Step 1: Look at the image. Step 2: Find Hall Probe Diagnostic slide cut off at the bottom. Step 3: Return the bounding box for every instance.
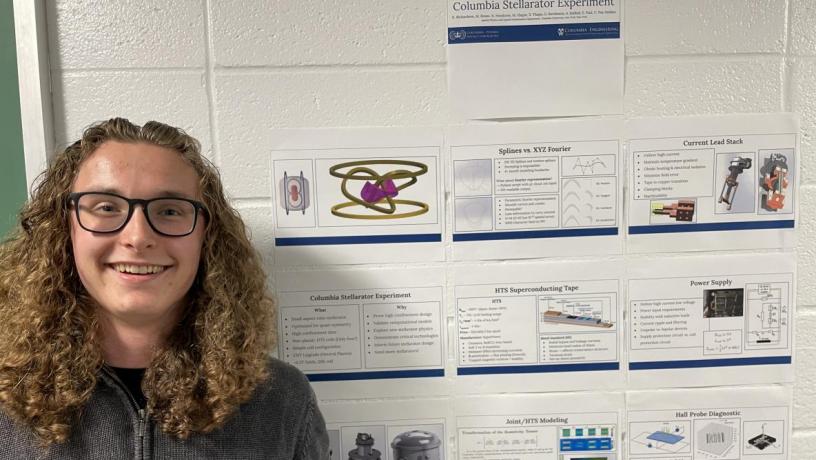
[626,386,792,460]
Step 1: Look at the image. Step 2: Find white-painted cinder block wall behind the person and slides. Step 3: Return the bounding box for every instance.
[46,0,816,459]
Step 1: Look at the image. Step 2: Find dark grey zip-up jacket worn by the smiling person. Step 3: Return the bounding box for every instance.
[0,359,329,460]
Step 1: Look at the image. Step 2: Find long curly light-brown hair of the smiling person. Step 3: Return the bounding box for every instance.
[0,118,275,445]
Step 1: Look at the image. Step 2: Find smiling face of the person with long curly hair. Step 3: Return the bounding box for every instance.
[71,141,206,327]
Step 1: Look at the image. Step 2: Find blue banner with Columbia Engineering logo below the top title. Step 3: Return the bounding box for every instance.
[448,22,620,45]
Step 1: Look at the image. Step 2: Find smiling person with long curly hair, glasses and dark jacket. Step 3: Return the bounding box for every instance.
[0,118,329,460]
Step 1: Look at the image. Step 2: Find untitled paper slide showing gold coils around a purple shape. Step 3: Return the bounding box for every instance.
[270,128,444,265]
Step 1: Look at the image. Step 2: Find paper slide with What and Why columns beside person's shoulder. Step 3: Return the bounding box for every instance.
[275,268,446,399]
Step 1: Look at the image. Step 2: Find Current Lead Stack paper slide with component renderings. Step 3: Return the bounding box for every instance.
[627,114,799,252]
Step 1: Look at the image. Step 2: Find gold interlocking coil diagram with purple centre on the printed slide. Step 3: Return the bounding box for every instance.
[329,160,429,219]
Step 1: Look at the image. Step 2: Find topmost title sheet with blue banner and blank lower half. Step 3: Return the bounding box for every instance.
[447,0,623,119]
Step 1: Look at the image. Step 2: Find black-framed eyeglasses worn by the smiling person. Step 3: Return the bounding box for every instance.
[68,192,207,236]
